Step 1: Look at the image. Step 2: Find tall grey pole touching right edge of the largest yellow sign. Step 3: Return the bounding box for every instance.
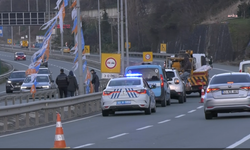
[121,0,124,75]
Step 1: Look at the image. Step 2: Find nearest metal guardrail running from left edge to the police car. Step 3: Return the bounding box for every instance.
[0,92,102,132]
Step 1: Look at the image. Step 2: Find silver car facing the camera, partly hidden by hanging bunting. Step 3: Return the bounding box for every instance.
[21,74,56,92]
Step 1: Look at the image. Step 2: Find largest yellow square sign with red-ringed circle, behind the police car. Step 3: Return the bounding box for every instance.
[101,53,121,73]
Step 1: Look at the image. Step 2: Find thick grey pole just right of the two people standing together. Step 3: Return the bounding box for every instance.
[76,0,84,95]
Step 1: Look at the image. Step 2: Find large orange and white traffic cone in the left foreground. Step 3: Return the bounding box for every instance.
[54,113,67,148]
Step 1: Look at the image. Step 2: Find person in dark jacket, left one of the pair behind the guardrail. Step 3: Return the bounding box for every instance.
[56,69,69,98]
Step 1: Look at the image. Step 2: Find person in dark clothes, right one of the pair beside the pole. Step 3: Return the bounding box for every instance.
[68,71,78,97]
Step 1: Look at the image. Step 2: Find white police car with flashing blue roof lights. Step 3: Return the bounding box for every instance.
[101,74,156,116]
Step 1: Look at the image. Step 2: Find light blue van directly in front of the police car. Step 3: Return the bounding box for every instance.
[125,64,170,107]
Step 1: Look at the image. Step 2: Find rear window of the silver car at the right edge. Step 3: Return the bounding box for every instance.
[210,74,250,84]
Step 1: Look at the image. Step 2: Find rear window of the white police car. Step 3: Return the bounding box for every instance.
[108,79,141,86]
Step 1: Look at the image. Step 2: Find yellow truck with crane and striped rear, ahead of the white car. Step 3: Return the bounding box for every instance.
[164,50,211,95]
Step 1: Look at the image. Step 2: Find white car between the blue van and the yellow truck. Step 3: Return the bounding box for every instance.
[165,69,186,103]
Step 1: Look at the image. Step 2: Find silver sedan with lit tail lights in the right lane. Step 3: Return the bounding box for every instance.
[204,72,250,119]
